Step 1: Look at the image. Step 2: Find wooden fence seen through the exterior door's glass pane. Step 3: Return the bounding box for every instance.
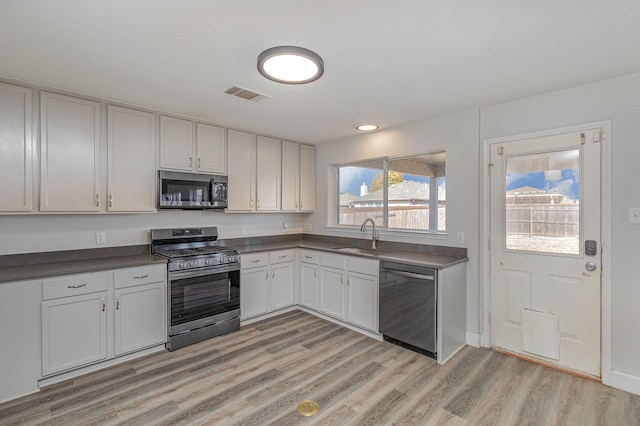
[506,204,580,237]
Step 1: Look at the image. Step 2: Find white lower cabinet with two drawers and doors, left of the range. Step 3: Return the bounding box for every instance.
[41,264,167,377]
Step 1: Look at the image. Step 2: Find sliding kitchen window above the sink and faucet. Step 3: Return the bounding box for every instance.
[336,151,447,232]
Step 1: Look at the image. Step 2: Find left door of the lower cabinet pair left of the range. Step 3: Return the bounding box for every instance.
[42,292,107,376]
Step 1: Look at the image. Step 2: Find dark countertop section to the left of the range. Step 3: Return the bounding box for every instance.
[0,254,167,284]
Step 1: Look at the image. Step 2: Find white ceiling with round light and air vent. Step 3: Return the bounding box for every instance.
[0,0,640,143]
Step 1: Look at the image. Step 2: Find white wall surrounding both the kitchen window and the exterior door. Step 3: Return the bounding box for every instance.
[310,74,640,394]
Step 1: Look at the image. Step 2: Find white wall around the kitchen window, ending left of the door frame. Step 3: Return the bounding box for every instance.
[308,108,479,335]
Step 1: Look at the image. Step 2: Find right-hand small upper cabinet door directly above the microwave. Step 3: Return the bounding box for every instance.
[196,123,227,175]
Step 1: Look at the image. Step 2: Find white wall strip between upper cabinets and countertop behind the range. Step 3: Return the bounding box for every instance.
[0,211,308,255]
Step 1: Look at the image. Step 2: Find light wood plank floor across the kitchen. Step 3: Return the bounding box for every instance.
[0,311,640,425]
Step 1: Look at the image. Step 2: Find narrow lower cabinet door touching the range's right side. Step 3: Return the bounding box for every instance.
[240,267,269,320]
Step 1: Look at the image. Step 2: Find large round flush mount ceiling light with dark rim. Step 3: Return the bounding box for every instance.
[258,46,324,84]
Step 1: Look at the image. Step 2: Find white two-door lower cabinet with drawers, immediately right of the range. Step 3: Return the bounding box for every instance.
[240,250,295,320]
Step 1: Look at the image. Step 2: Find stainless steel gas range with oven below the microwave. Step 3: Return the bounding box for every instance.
[151,227,240,351]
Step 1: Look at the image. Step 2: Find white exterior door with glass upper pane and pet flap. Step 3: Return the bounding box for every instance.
[490,128,603,376]
